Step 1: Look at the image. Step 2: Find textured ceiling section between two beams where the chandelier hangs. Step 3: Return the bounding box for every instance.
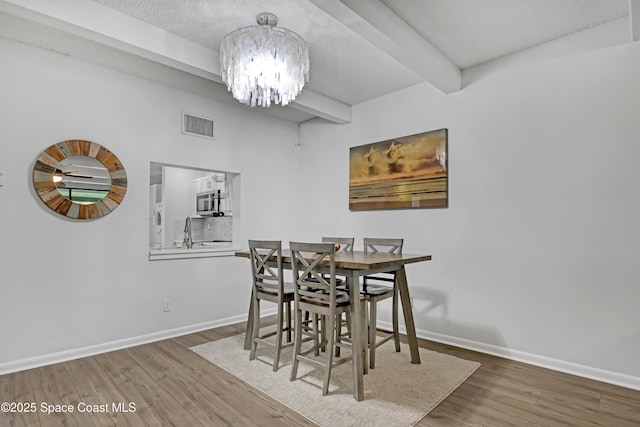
[86,0,421,105]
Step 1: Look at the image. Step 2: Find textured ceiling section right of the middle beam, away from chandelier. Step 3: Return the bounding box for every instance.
[383,0,629,69]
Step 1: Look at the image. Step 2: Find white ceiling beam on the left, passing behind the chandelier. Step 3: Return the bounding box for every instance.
[0,0,351,124]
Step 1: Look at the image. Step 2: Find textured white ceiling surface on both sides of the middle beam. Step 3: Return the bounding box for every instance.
[86,0,629,105]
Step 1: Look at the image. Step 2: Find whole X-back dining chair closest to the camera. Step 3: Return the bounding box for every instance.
[289,242,365,396]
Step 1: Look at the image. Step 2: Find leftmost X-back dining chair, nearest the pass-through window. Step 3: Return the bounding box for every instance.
[249,240,294,371]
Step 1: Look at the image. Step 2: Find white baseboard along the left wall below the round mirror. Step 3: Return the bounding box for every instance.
[0,310,250,375]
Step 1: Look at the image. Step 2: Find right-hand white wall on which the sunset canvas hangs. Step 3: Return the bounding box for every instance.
[302,43,640,388]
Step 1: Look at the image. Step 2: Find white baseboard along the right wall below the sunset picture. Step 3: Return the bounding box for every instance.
[378,322,640,390]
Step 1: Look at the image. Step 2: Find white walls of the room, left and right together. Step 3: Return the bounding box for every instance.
[0,30,640,388]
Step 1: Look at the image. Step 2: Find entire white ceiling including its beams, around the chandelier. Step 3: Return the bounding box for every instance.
[0,0,640,123]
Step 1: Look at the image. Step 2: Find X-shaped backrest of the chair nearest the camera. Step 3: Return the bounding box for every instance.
[289,242,336,312]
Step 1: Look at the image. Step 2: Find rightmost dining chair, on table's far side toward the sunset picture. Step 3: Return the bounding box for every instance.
[361,237,403,369]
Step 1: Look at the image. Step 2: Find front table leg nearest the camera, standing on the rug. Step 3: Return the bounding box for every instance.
[346,271,366,401]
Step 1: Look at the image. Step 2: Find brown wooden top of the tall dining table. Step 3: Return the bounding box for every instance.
[235,249,431,270]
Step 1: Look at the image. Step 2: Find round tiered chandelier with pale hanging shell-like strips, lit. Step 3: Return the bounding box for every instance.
[220,13,309,107]
